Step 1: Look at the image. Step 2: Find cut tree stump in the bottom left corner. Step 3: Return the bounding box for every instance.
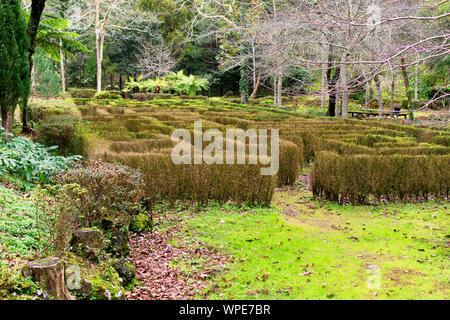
[24,257,75,300]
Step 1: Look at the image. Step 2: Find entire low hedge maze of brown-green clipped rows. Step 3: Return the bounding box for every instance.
[75,97,450,204]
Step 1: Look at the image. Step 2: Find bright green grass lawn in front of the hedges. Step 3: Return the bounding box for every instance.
[173,189,450,299]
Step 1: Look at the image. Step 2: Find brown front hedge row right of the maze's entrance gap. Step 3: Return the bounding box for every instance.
[312,151,450,204]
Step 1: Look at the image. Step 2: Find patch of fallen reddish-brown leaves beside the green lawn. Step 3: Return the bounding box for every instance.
[126,214,229,300]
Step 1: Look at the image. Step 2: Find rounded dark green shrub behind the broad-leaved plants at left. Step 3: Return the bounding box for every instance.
[37,117,87,155]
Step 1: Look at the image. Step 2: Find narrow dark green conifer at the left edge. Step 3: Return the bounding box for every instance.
[0,0,30,132]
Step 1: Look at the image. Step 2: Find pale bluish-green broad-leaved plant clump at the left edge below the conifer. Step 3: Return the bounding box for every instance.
[0,128,81,186]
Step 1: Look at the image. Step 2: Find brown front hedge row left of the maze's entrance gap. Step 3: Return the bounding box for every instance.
[104,154,277,205]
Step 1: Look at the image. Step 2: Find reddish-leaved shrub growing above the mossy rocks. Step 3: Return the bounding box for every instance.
[55,161,143,228]
